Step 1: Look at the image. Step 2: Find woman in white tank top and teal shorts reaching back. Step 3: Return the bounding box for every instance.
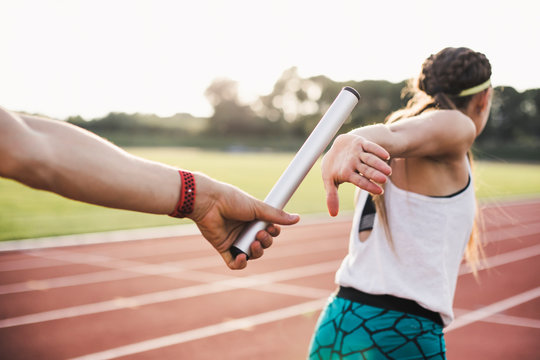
[309,48,492,359]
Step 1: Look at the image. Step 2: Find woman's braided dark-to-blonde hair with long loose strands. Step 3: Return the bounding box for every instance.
[373,48,491,276]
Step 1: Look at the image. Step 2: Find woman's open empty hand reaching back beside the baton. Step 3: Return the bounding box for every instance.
[321,134,392,216]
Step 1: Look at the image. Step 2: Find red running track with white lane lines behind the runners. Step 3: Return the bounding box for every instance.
[0,199,540,360]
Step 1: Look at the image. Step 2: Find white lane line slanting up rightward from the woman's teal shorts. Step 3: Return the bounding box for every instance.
[445,286,540,332]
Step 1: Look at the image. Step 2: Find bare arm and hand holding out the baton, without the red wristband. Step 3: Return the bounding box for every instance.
[0,108,299,269]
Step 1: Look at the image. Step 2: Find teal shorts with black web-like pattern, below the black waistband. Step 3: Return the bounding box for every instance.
[309,296,446,360]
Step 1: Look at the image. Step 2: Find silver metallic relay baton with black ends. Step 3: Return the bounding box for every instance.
[230,86,360,258]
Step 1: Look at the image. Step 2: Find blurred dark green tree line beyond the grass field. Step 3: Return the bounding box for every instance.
[68,67,540,160]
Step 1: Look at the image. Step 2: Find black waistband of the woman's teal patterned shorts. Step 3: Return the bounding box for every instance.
[336,286,443,326]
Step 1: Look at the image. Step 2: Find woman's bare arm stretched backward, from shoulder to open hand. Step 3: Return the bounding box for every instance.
[322,110,476,216]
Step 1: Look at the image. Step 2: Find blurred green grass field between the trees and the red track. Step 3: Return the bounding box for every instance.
[0,148,540,240]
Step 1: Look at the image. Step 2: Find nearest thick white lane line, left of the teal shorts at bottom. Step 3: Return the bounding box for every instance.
[72,298,327,360]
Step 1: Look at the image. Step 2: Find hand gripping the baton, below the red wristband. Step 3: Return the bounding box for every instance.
[189,173,300,269]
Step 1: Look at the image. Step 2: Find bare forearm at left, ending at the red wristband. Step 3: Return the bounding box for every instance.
[0,110,180,214]
